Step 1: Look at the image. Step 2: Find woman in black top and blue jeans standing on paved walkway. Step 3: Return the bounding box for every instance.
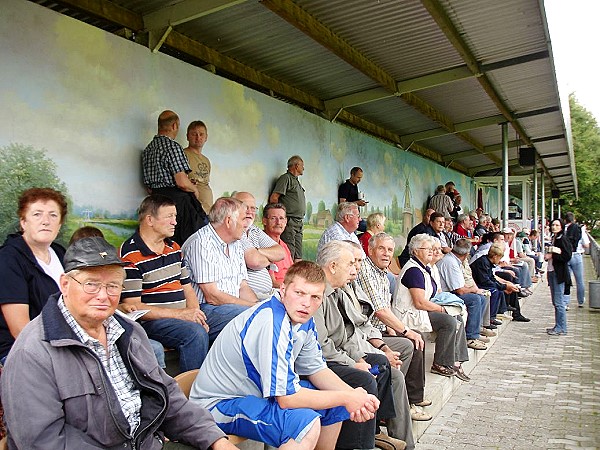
[544,219,572,336]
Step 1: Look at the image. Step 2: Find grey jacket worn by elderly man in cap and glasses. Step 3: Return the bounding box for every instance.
[1,293,224,450]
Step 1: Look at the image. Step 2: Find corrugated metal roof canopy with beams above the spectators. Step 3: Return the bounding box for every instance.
[30,0,577,195]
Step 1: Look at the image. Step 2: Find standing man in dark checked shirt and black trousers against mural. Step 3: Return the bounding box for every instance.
[142,110,207,245]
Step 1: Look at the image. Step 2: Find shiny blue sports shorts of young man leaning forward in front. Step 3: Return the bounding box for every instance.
[210,381,350,447]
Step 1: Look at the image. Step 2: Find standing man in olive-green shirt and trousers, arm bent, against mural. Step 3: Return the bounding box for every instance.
[269,155,306,261]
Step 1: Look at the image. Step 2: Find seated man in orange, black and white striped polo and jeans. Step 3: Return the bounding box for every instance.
[120,194,209,372]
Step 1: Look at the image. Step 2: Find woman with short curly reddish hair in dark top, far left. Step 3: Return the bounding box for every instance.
[0,188,67,363]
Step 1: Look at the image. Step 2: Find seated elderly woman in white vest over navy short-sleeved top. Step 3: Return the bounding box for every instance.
[392,234,469,381]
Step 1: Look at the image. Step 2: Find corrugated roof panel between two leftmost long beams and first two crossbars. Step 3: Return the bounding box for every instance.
[177,2,376,99]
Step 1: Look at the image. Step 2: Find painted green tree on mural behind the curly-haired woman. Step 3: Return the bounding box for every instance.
[0,144,71,243]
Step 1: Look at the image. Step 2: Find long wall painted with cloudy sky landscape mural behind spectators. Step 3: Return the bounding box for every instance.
[0,0,478,257]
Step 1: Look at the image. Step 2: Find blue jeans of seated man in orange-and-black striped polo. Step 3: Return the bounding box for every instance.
[141,319,208,372]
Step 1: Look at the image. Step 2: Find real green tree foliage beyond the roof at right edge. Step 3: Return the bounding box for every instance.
[562,94,600,227]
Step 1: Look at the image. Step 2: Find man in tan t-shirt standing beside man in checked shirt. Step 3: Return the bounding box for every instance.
[183,120,213,214]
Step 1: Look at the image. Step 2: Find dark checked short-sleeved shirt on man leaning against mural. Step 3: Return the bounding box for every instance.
[142,135,191,189]
